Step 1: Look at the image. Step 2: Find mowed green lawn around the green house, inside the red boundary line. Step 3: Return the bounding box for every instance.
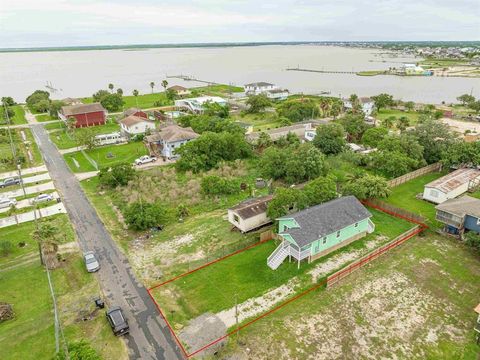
[153,209,412,324]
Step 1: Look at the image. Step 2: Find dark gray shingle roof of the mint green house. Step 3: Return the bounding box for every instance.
[280,196,372,247]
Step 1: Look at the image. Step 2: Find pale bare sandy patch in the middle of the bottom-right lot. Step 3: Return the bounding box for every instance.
[284,272,465,359]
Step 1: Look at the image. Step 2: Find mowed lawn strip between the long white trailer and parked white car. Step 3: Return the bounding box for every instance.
[63,142,147,172]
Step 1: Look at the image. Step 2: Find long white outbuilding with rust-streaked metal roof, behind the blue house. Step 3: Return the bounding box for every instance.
[423,168,480,204]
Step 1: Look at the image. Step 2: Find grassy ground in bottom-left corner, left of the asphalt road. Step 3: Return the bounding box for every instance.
[0,215,126,360]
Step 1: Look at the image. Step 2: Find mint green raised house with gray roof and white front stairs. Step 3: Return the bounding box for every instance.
[267,196,375,270]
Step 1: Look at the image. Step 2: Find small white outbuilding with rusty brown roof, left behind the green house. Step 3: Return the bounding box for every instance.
[228,195,273,233]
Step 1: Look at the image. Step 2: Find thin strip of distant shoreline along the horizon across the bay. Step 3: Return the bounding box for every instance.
[0,41,480,53]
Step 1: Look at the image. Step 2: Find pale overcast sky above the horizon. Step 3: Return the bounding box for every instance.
[0,0,480,48]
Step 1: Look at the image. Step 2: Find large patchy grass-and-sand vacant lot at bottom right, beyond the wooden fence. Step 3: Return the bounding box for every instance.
[219,233,480,360]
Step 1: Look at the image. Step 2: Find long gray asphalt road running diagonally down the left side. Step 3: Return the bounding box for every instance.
[30,124,183,360]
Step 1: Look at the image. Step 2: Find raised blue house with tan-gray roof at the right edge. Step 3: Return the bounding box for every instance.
[435,195,480,235]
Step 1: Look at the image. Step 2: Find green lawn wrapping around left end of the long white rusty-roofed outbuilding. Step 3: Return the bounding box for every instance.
[385,172,445,227]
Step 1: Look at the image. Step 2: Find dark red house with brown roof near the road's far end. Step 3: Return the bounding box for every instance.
[58,103,107,128]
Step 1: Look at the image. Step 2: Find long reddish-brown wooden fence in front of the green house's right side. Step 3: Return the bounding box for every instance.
[327,225,424,288]
